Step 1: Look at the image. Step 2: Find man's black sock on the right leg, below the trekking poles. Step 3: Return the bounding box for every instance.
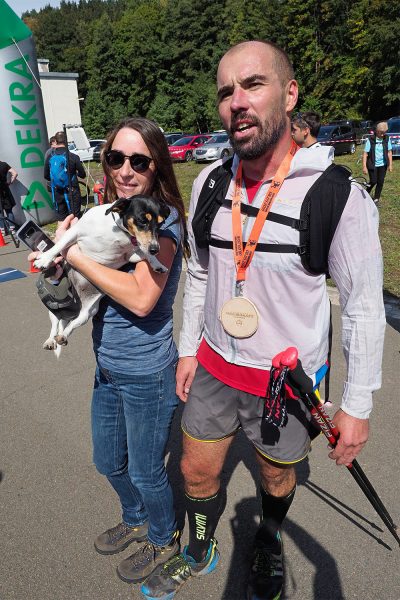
[256,486,296,546]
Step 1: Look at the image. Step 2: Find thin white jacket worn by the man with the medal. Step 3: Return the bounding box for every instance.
[179,147,386,418]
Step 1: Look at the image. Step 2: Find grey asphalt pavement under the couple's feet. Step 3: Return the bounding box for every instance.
[0,243,400,600]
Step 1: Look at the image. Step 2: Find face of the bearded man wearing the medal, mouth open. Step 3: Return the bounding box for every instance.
[217,42,297,160]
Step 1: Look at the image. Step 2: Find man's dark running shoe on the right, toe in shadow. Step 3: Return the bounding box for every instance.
[247,531,283,600]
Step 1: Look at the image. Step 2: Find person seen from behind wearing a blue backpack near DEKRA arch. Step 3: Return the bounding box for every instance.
[44,131,86,221]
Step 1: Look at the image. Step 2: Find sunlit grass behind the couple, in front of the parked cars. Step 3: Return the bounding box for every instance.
[54,146,400,297]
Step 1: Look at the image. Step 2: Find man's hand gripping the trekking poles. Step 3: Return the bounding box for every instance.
[329,409,369,466]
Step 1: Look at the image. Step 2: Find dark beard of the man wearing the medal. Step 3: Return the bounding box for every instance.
[229,111,287,160]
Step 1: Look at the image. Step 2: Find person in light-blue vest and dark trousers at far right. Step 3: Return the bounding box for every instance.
[363,121,393,205]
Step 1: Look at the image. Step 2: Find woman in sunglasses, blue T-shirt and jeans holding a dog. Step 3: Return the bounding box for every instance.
[52,118,186,582]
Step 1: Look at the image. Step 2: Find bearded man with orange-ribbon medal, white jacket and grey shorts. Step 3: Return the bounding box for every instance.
[142,41,385,600]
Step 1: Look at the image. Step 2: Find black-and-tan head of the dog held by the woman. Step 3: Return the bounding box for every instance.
[106,194,170,254]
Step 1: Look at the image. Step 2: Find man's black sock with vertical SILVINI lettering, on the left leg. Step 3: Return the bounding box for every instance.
[185,489,223,562]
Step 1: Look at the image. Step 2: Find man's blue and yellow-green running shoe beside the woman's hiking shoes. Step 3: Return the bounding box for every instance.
[140,538,219,600]
